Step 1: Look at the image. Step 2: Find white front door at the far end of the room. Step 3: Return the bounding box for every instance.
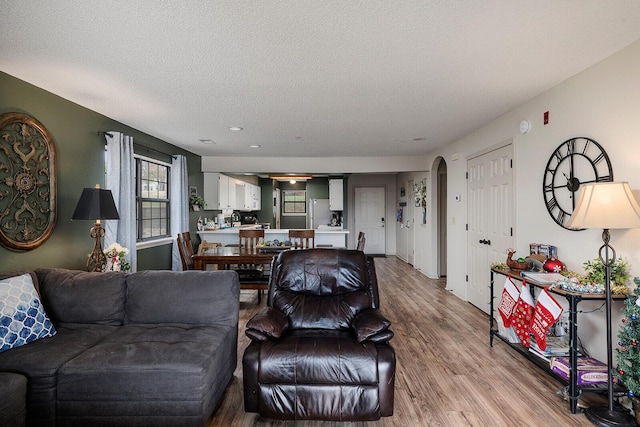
[354,187,386,254]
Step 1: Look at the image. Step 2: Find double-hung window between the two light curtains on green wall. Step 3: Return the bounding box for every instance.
[135,156,171,242]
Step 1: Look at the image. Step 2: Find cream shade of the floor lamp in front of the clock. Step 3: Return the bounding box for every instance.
[567,182,640,229]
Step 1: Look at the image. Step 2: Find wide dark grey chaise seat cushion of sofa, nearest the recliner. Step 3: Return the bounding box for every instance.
[58,324,238,425]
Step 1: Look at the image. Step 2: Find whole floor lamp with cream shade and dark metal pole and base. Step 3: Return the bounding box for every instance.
[567,182,640,426]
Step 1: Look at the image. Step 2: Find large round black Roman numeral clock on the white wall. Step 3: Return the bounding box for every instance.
[542,137,613,230]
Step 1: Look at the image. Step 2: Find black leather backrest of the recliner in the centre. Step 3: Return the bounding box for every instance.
[267,249,378,330]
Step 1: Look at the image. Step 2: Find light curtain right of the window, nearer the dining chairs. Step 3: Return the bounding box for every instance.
[169,156,189,271]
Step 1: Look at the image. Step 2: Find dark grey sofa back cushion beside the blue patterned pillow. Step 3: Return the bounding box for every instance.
[35,268,127,325]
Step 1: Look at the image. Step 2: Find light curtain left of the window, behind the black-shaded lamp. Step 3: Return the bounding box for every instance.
[104,131,137,272]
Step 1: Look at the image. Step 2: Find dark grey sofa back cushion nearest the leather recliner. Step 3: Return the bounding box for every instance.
[126,271,240,325]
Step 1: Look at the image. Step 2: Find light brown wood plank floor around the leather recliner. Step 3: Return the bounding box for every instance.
[209,257,591,427]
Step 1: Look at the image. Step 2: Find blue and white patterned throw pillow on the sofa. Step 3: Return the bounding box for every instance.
[0,274,56,352]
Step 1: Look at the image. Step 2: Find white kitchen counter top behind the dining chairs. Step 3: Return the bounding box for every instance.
[198,229,349,248]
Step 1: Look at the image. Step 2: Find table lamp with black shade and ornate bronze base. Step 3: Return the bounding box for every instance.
[71,184,120,271]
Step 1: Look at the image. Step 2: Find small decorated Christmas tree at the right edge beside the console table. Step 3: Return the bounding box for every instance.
[615,277,640,397]
